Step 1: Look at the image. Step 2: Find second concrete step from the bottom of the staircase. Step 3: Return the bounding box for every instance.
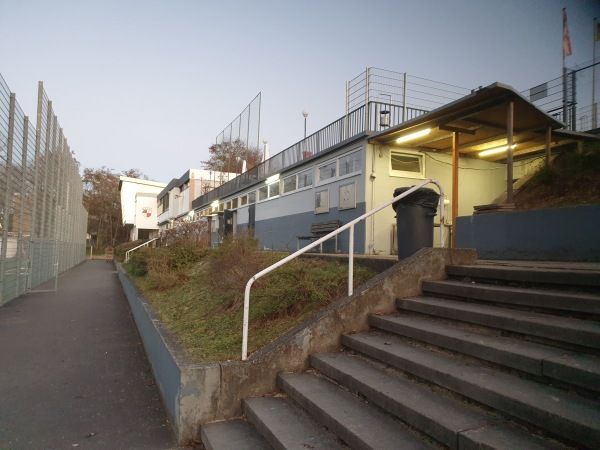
[243,397,345,450]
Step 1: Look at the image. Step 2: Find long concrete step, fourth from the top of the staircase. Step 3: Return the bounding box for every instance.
[369,314,600,392]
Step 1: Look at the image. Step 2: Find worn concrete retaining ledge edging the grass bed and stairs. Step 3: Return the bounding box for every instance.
[118,248,477,445]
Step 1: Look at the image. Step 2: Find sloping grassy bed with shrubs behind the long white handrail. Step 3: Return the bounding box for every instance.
[125,234,376,362]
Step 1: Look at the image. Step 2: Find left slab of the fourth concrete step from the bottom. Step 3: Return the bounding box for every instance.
[311,353,502,449]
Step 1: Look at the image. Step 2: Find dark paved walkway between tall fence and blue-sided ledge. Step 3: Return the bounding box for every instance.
[0,261,177,450]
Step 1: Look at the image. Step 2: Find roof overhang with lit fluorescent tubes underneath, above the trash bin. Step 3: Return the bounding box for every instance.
[369,83,573,162]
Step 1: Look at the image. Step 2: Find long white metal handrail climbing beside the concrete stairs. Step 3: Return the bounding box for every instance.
[242,179,444,360]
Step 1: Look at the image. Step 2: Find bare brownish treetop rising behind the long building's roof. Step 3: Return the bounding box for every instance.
[202,139,262,173]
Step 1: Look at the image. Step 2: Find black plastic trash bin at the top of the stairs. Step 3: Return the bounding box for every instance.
[392,187,440,259]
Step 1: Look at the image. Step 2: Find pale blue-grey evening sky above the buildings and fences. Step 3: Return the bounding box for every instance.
[0,0,600,182]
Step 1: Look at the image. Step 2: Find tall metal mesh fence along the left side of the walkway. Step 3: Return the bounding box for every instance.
[0,75,87,305]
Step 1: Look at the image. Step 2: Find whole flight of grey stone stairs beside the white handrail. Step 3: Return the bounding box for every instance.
[201,263,600,450]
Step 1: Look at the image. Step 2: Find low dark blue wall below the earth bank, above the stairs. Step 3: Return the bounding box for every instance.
[455,205,600,262]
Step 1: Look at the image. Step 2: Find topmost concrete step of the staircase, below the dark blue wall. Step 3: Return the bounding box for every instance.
[446,263,600,288]
